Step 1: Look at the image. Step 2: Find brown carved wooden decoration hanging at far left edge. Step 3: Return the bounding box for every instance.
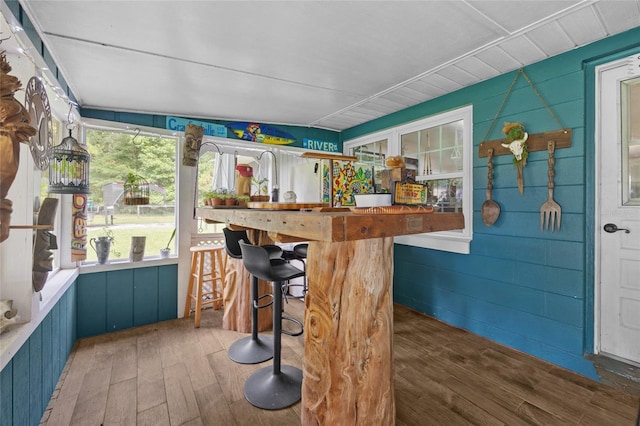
[0,46,36,242]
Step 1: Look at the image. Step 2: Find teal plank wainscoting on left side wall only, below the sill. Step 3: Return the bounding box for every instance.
[0,282,77,426]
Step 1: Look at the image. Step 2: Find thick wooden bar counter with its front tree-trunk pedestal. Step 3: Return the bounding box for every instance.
[196,207,464,425]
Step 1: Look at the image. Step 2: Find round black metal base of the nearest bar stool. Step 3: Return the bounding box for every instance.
[244,365,302,410]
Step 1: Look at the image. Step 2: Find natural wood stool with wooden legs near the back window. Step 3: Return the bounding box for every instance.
[184,246,225,328]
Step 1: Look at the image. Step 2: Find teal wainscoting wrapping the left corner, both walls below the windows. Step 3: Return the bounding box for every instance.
[0,265,178,426]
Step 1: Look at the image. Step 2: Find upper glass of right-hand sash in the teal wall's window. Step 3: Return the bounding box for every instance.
[400,120,463,176]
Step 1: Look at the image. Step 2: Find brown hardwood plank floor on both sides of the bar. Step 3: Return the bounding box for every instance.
[41,300,640,426]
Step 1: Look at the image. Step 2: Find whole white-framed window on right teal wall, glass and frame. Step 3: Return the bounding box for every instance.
[344,106,473,253]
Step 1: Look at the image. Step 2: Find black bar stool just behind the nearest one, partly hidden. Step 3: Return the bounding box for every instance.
[222,228,282,364]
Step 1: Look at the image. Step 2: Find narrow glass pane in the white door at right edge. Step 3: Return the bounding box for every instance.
[622,78,640,205]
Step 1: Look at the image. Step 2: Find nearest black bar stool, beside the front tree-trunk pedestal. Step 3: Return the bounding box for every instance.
[240,241,304,410]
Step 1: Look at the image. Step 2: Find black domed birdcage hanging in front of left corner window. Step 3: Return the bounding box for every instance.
[49,129,91,194]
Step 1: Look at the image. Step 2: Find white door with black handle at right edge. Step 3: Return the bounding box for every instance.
[596,55,640,363]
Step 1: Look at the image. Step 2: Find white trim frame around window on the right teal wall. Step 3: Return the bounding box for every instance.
[343,105,473,254]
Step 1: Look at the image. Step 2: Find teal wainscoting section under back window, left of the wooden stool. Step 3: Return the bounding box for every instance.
[77,265,178,338]
